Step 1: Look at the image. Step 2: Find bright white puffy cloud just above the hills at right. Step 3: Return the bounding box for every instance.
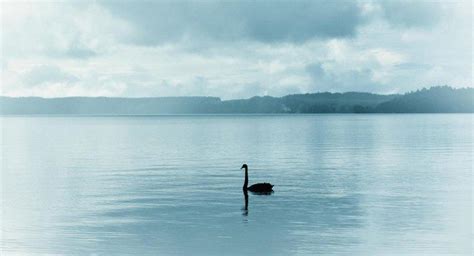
[305,40,407,93]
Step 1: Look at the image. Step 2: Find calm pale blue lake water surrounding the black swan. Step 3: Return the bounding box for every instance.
[0,114,474,255]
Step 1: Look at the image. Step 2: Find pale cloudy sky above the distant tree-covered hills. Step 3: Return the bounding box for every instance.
[0,0,473,99]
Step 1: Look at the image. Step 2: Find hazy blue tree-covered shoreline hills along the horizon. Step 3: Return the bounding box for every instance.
[0,86,474,115]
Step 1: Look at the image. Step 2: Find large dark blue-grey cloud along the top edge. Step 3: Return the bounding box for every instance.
[101,0,363,45]
